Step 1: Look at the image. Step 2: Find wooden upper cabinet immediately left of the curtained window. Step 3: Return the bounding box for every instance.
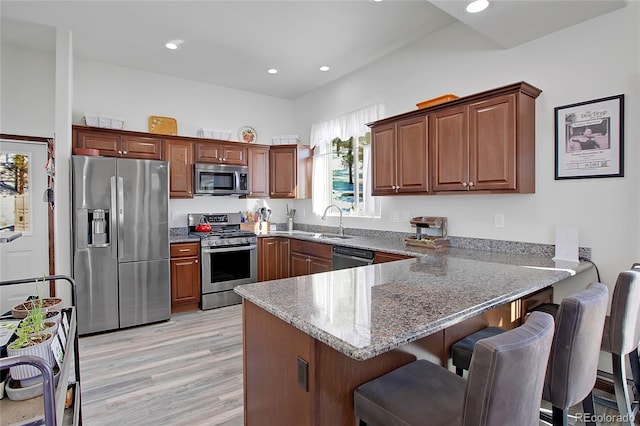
[269,145,311,198]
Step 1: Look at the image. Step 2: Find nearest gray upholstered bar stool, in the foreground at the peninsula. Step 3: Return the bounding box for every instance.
[354,312,554,426]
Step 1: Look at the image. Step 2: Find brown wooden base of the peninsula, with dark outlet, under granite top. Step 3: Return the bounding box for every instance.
[242,300,415,426]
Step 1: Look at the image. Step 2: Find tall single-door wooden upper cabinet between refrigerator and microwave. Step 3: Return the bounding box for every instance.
[164,140,193,198]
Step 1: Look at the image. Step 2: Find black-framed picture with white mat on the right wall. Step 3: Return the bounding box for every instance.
[554,95,624,180]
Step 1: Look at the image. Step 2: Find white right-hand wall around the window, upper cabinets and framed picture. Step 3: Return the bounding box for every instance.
[294,2,640,285]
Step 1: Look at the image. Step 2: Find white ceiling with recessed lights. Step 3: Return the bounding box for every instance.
[0,0,626,99]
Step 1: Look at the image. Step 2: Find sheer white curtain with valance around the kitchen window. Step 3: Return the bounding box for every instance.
[309,103,384,215]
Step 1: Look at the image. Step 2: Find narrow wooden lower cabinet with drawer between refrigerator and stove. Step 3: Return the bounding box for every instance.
[171,243,200,312]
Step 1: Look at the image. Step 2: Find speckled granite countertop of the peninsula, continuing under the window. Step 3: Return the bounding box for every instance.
[235,243,593,360]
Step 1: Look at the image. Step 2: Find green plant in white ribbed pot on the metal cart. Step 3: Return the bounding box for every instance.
[7,297,57,380]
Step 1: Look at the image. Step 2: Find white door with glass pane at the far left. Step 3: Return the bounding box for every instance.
[0,139,49,314]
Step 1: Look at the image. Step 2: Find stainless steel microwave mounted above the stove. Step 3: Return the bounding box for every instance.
[193,163,249,195]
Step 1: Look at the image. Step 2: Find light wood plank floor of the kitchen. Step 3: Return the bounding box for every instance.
[80,305,640,426]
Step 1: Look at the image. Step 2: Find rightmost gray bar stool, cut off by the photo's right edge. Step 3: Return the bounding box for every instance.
[597,265,640,425]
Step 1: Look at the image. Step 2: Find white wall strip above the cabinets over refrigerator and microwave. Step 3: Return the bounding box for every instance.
[73,58,293,144]
